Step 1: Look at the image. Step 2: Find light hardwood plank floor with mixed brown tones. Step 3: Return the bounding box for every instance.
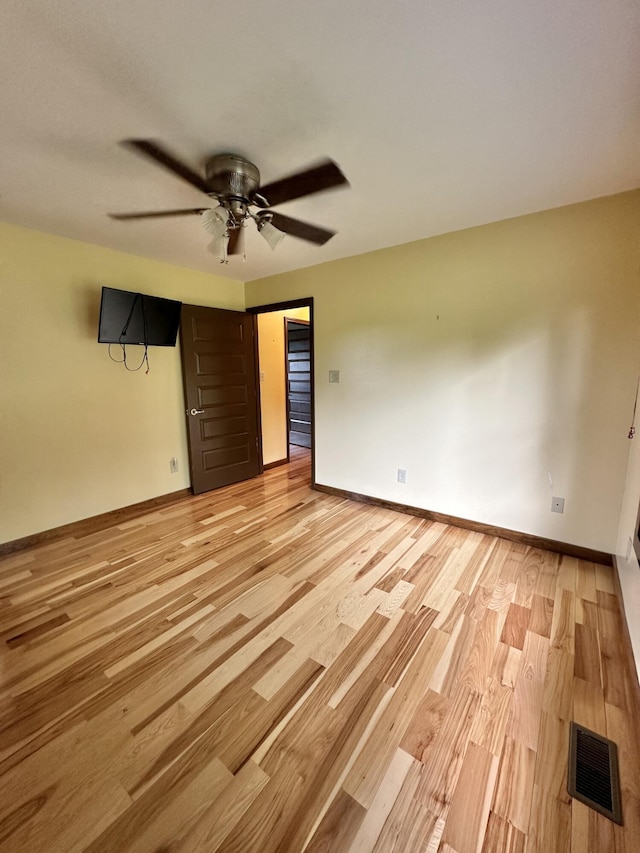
[0,454,640,853]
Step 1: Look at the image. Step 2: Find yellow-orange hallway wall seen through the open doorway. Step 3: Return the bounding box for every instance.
[258,308,309,465]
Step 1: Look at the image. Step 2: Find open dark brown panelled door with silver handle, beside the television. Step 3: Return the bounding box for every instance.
[180,305,261,494]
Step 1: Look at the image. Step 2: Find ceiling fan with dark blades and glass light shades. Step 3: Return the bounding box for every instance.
[108,139,349,263]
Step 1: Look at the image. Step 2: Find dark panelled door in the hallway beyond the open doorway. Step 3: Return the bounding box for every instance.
[284,318,311,447]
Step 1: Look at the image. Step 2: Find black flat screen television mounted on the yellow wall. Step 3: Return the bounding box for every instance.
[98,287,182,347]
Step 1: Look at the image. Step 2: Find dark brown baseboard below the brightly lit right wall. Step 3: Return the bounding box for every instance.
[314,483,613,566]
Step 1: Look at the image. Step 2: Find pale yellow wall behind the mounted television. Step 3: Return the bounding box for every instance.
[0,224,244,541]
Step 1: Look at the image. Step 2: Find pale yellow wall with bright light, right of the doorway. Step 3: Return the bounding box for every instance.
[246,191,640,553]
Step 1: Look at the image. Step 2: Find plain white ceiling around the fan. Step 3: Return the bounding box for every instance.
[0,0,640,281]
